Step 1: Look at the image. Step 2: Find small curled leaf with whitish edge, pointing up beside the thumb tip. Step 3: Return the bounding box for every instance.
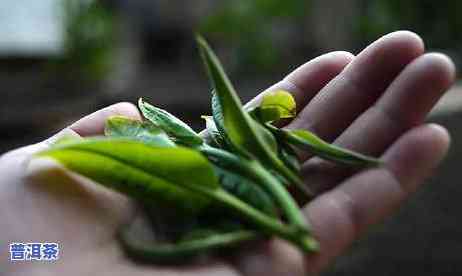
[138,99,203,146]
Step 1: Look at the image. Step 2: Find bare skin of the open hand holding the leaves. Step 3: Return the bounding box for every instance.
[0,31,455,276]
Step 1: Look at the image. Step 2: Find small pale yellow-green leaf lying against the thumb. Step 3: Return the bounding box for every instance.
[104,116,176,147]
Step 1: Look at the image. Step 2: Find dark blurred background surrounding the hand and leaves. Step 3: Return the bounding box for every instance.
[0,0,462,275]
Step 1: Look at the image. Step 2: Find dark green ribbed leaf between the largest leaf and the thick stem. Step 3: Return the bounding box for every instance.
[214,166,277,217]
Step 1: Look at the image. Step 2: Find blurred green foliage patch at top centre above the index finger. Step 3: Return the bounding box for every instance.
[199,0,307,71]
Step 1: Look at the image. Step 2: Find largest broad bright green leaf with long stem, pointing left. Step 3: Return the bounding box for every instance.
[35,138,316,254]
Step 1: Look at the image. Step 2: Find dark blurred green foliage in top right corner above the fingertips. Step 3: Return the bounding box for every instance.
[356,0,462,51]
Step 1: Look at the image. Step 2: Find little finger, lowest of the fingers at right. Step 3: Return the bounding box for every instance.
[306,125,449,270]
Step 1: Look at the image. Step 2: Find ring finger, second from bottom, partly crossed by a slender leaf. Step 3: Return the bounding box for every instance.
[303,54,455,192]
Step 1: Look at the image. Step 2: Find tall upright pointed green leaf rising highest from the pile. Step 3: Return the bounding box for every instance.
[197,37,313,229]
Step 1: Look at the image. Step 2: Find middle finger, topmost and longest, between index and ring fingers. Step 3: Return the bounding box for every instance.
[289,31,424,141]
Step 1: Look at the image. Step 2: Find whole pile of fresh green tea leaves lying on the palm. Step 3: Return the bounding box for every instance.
[37,37,380,263]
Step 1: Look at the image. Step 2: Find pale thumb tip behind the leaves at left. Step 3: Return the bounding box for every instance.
[70,102,141,136]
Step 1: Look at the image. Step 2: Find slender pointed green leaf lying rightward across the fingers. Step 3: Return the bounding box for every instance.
[279,129,381,166]
